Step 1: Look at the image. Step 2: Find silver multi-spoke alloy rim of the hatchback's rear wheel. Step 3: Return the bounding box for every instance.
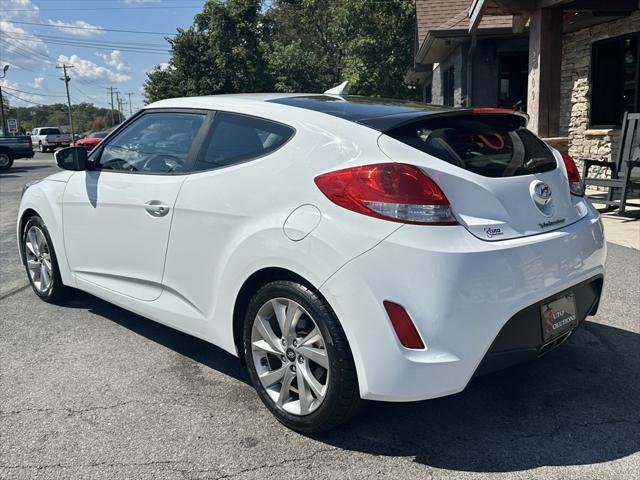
[251,298,329,416]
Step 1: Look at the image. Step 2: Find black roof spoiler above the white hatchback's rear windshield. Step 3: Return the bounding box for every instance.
[356,107,529,133]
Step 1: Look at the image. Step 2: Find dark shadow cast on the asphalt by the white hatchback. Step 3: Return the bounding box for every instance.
[65,293,640,472]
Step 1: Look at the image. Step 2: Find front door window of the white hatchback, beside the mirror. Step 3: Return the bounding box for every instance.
[99,113,205,173]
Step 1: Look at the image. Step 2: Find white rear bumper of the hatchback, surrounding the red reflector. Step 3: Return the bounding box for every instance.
[321,205,606,401]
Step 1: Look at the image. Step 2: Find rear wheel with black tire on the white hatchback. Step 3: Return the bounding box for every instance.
[243,281,364,433]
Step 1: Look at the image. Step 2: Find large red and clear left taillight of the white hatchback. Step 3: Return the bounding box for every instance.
[315,163,458,225]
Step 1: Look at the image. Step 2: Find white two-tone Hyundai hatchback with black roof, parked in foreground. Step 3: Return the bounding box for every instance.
[17,94,605,432]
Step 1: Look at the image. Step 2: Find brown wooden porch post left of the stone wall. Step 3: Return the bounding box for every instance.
[527,8,562,137]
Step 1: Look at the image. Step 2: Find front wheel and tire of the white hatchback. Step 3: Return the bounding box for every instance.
[21,215,72,303]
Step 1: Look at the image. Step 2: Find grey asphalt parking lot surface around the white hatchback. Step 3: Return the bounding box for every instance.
[0,154,640,479]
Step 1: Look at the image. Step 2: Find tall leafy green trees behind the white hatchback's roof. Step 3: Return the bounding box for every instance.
[144,0,415,102]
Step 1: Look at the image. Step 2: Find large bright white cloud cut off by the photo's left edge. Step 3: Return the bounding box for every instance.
[0,20,51,69]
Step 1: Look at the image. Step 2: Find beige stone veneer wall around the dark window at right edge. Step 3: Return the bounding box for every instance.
[560,11,640,174]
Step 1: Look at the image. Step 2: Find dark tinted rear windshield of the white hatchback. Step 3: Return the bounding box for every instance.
[386,113,557,177]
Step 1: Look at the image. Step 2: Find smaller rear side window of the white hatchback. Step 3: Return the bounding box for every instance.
[194,112,294,170]
